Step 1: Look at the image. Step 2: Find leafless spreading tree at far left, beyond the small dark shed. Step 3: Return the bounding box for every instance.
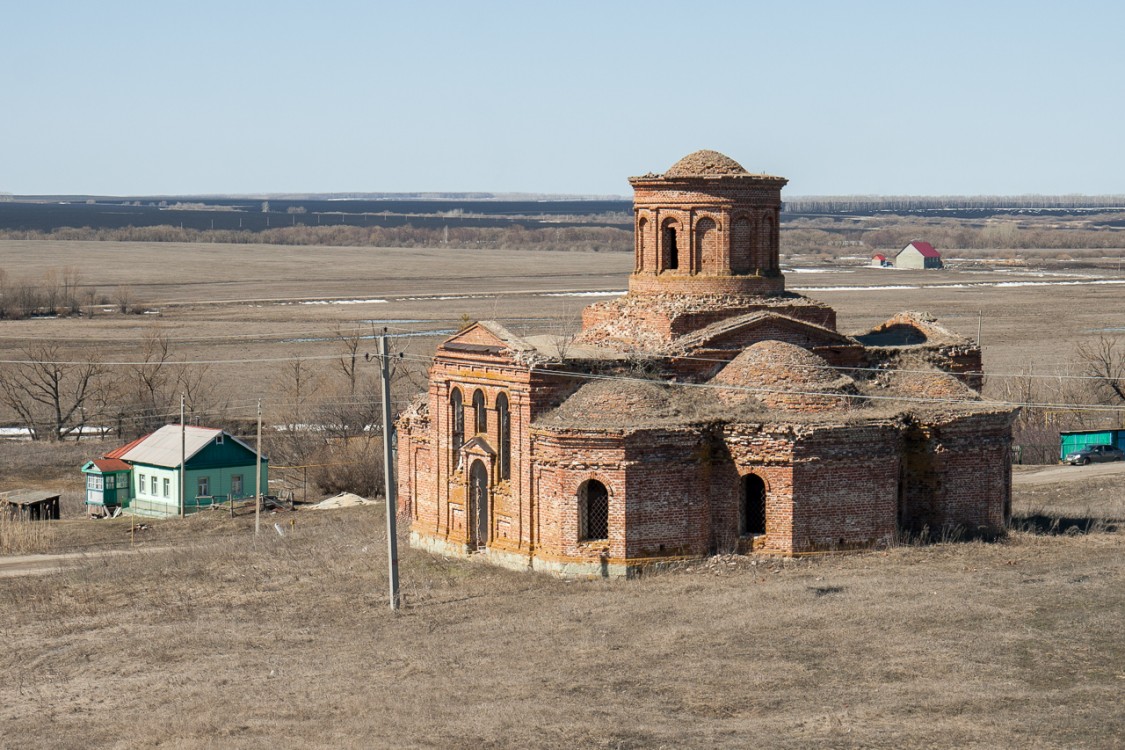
[0,344,105,441]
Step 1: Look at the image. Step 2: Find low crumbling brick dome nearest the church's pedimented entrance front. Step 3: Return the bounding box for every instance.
[541,380,681,427]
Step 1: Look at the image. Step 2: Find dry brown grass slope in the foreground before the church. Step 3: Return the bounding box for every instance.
[0,469,1125,749]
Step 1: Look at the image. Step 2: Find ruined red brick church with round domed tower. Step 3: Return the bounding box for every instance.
[398,151,1014,576]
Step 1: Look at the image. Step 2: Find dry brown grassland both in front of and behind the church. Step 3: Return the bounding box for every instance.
[0,242,1125,750]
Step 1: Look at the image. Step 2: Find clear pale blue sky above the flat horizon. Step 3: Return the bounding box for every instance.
[0,0,1125,196]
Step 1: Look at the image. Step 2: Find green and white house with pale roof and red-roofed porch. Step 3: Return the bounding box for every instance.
[83,425,269,516]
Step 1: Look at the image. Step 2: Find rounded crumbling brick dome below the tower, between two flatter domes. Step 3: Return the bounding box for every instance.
[711,341,858,412]
